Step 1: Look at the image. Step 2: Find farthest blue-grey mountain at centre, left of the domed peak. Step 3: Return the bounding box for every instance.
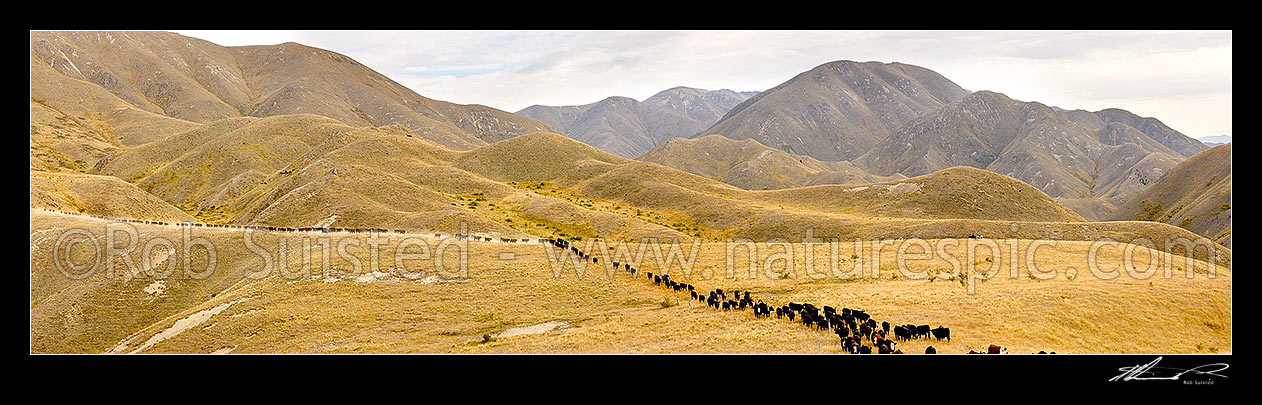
[517,87,750,158]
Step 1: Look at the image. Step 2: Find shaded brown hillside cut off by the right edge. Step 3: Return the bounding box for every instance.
[1113,144,1232,247]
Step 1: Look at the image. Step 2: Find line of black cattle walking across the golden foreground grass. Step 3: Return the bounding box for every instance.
[550,240,989,355]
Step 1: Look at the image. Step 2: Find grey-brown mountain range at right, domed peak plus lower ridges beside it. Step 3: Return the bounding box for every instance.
[593,61,1208,220]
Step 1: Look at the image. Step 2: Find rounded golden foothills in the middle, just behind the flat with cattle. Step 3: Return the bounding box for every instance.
[93,126,1225,264]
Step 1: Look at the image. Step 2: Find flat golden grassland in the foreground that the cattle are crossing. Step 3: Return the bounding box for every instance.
[32,211,1232,353]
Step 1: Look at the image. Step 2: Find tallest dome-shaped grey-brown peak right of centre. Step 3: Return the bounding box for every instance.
[695,61,968,161]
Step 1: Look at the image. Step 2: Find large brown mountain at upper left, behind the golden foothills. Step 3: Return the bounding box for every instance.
[30,32,551,150]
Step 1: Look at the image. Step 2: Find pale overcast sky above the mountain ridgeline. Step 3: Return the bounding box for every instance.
[179,30,1232,138]
